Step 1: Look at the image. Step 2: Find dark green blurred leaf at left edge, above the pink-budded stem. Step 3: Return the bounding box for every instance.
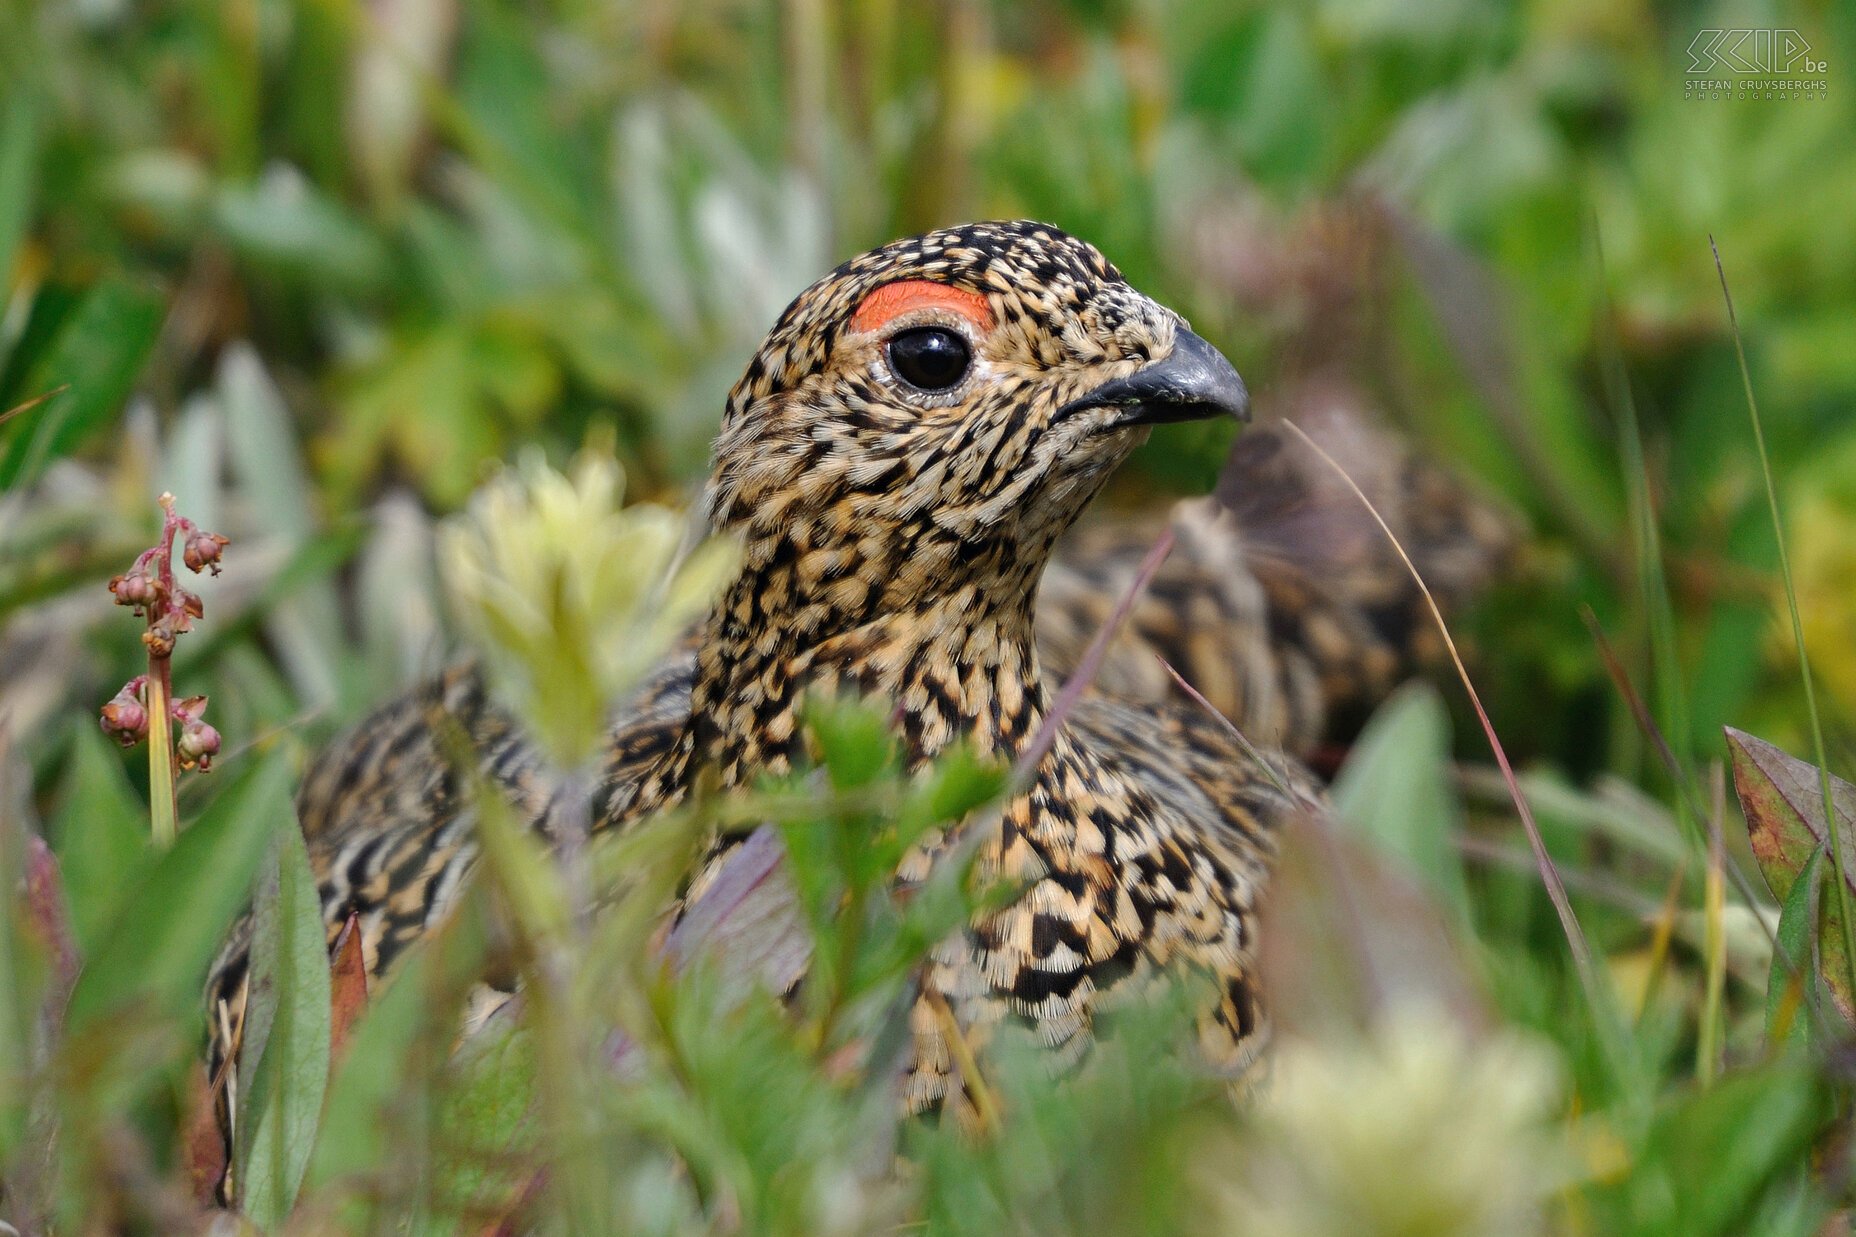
[0,279,165,490]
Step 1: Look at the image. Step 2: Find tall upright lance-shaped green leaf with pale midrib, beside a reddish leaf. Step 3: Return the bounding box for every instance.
[236,813,330,1230]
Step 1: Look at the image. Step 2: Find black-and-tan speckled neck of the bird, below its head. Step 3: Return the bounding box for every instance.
[692,544,1045,786]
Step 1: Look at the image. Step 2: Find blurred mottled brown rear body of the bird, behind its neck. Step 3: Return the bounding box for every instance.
[1038,416,1514,754]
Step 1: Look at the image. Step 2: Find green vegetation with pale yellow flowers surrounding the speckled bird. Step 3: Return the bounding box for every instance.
[0,0,1856,1233]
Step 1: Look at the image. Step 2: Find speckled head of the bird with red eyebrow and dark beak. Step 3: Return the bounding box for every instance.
[709,221,1247,617]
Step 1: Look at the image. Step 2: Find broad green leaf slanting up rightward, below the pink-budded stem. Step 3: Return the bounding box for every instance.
[69,756,291,1029]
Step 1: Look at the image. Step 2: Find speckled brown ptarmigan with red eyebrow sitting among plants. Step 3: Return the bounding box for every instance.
[210,223,1490,1136]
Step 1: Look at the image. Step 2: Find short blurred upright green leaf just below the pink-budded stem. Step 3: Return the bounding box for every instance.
[52,719,152,957]
